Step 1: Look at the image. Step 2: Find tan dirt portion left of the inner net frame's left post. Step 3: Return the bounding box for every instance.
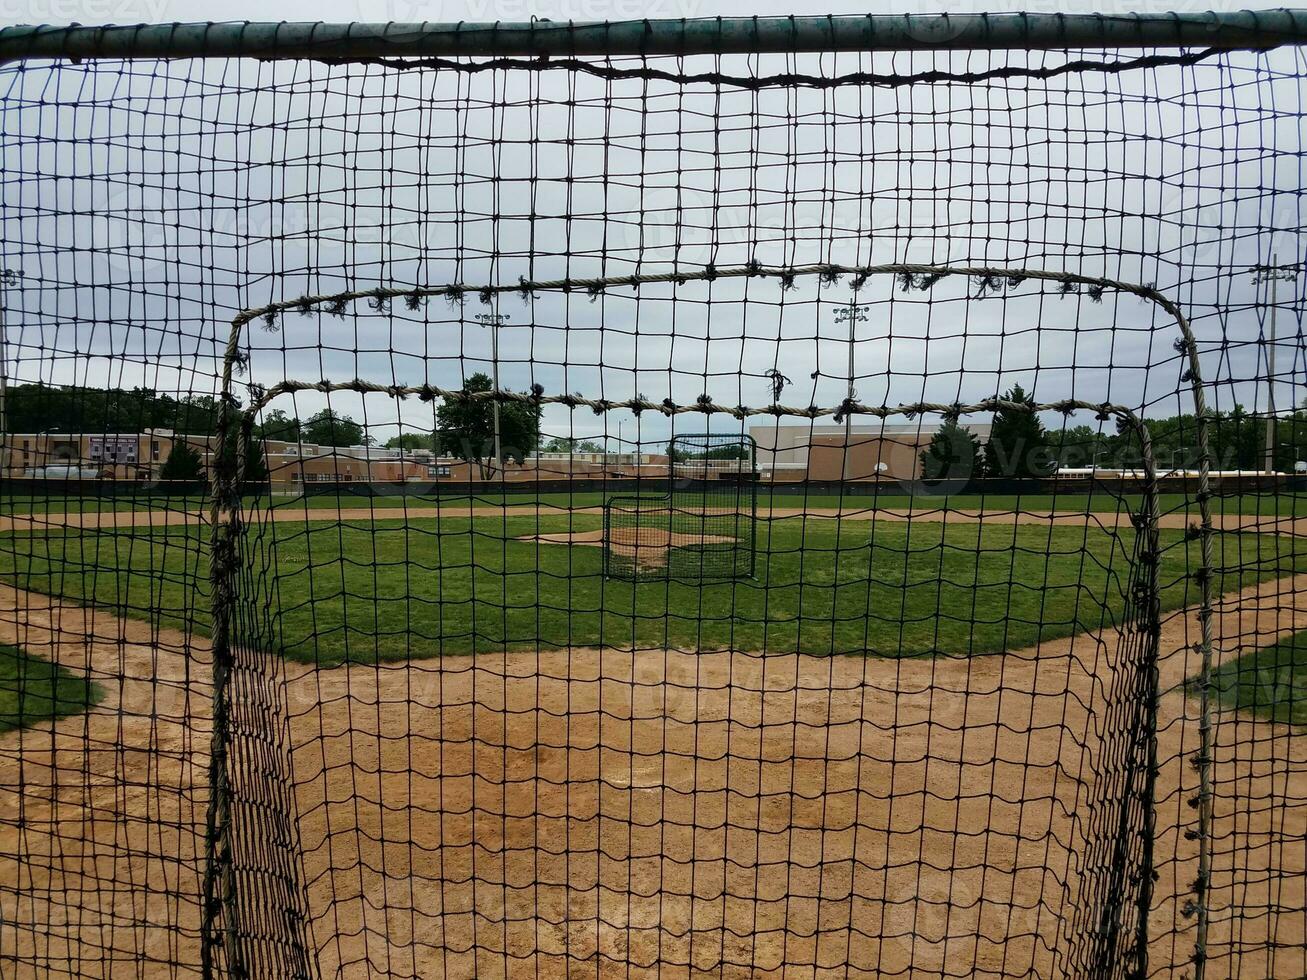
[0,585,212,980]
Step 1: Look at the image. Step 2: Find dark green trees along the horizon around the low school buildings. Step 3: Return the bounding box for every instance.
[5,372,1307,481]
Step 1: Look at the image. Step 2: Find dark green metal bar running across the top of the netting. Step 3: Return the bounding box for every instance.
[0,9,1307,64]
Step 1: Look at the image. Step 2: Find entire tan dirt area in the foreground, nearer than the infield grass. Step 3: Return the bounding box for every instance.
[0,575,1307,977]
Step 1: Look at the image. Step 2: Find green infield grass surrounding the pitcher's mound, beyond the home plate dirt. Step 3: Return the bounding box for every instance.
[0,515,1307,664]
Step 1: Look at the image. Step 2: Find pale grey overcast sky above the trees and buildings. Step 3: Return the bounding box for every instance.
[0,0,1307,452]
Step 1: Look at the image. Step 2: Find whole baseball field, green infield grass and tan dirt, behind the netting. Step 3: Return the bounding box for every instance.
[0,503,1307,977]
